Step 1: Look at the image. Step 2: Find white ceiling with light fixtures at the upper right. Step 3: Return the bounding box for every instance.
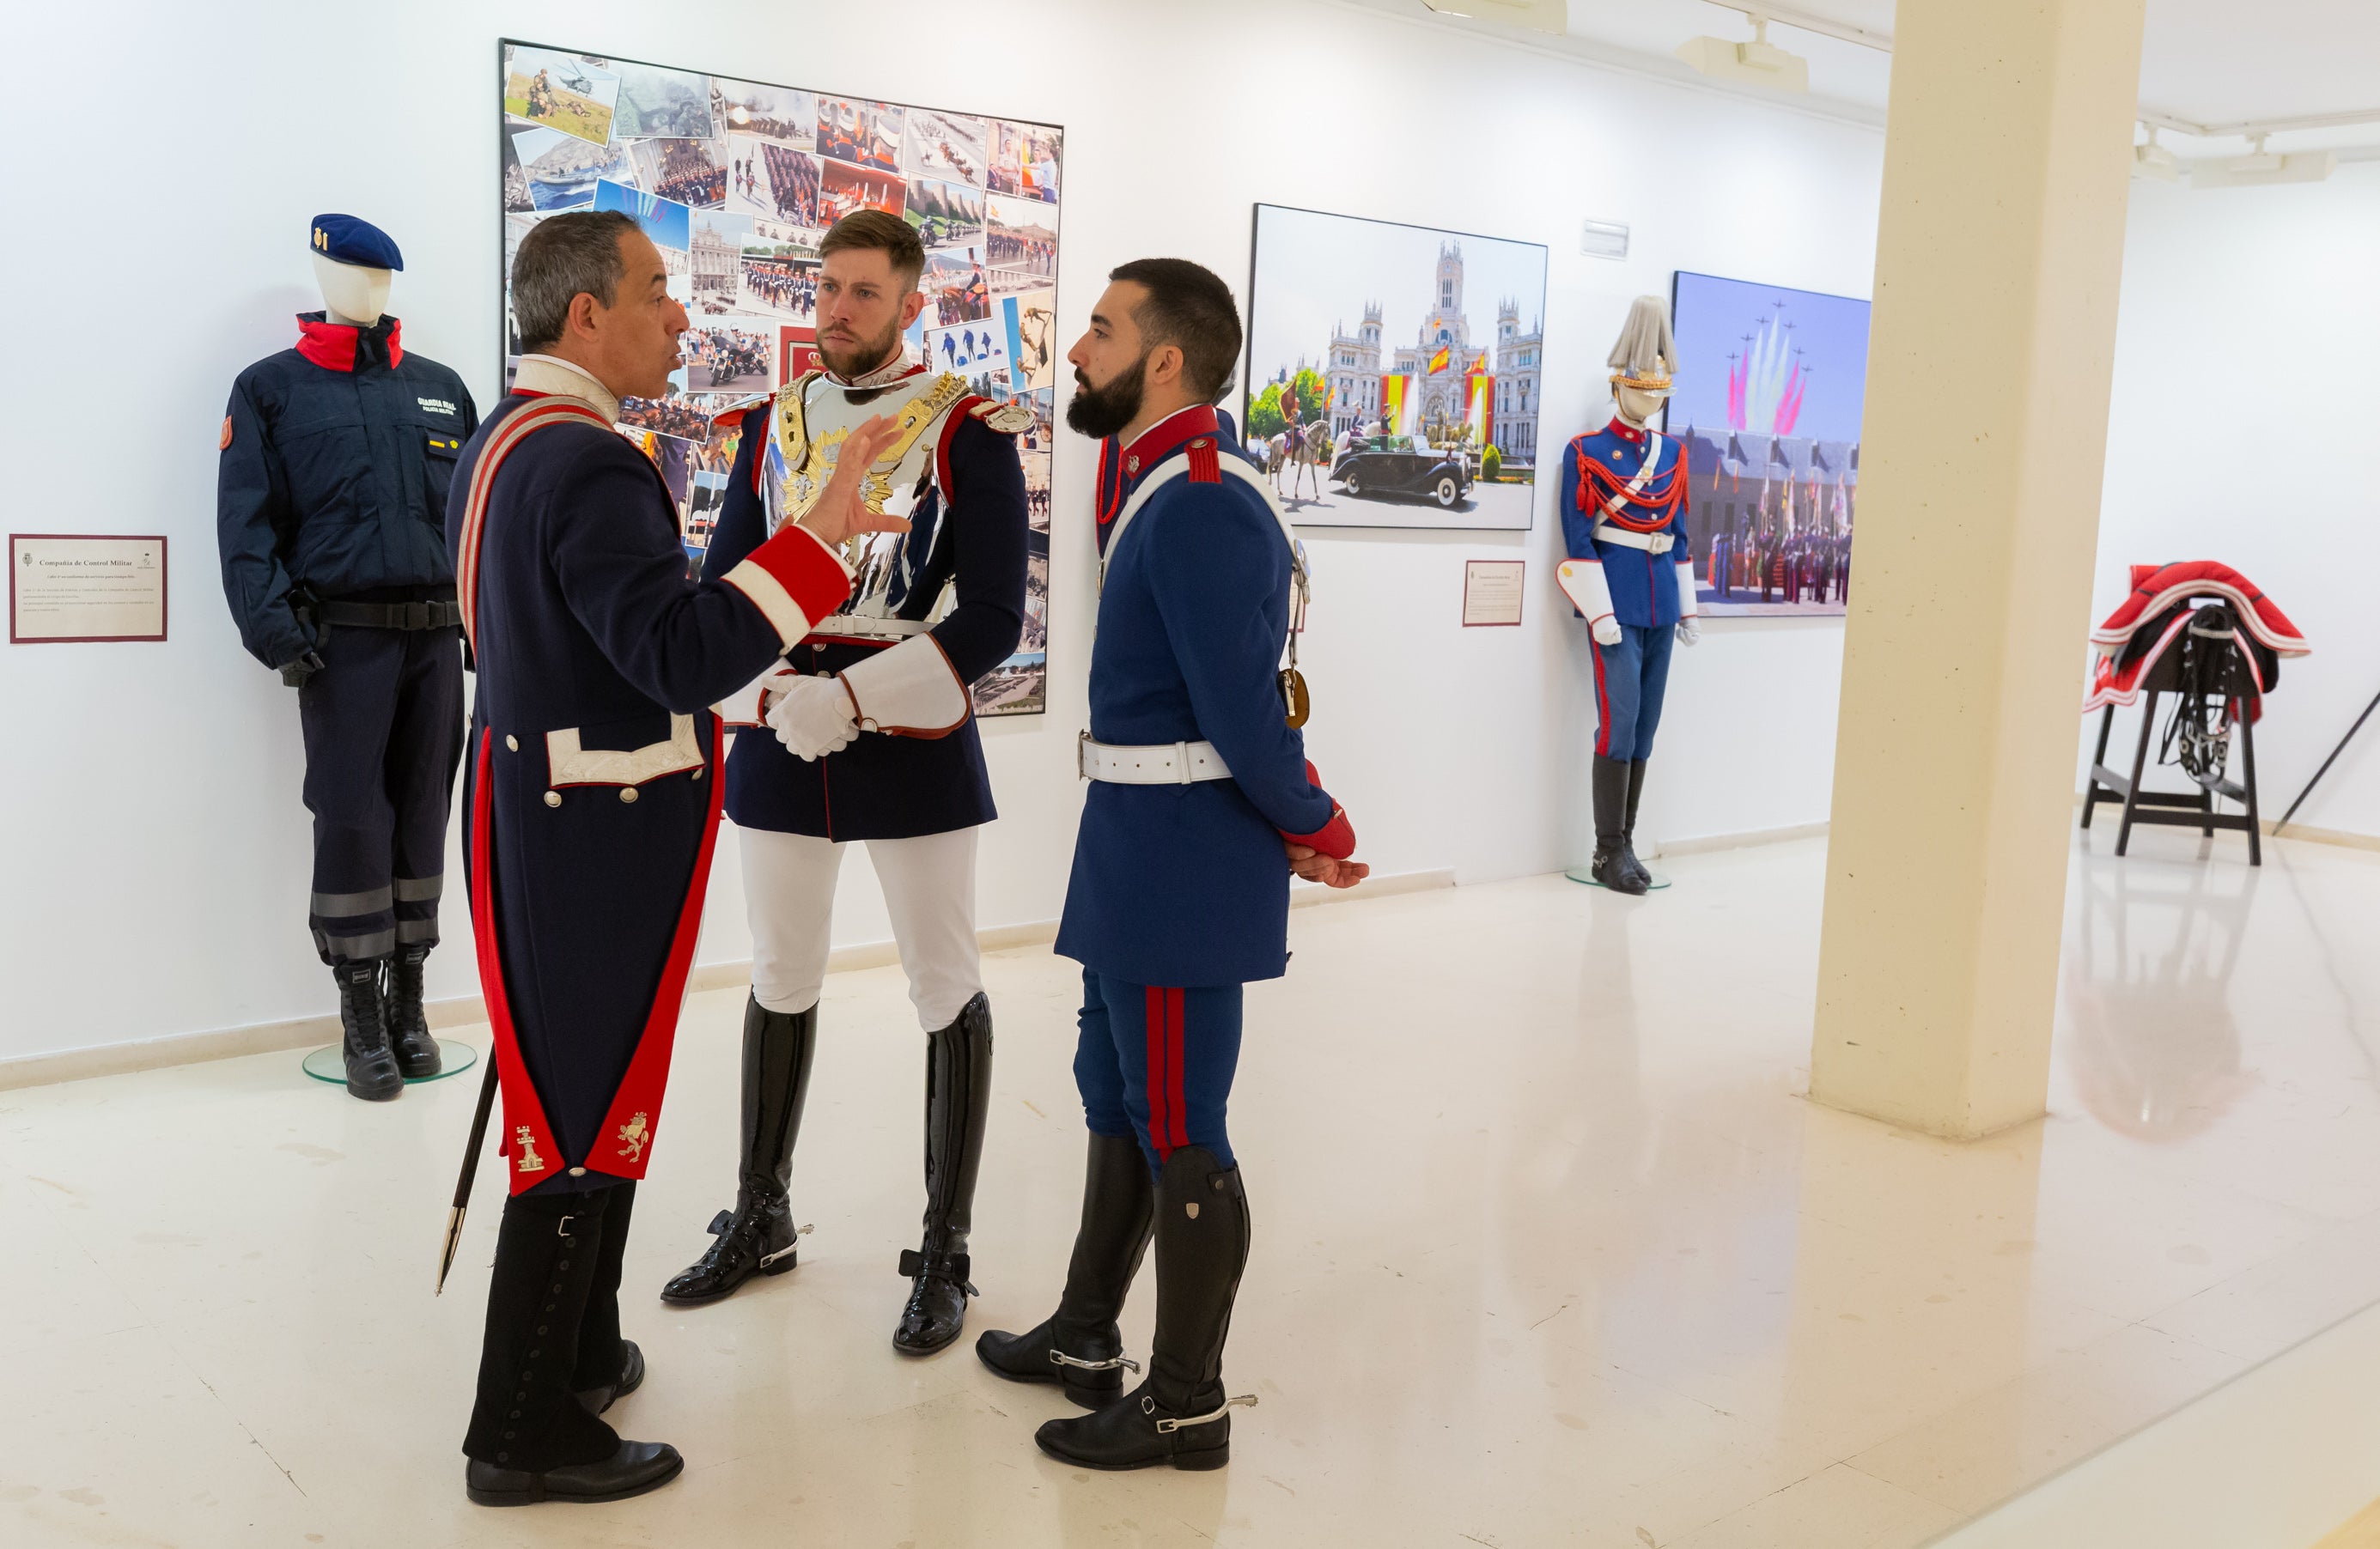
[1354,0,2380,157]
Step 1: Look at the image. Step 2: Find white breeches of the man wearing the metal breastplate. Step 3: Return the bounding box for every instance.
[735,828,983,1030]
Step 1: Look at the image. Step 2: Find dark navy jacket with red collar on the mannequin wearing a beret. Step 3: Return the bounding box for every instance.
[214,312,478,666]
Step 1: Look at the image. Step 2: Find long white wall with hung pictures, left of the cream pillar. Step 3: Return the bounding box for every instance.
[0,0,1894,1059]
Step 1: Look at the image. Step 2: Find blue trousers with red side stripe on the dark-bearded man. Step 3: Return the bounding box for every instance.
[1074,969,1240,1175]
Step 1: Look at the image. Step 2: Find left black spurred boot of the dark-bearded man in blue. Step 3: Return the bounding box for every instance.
[976,1135,1157,1409]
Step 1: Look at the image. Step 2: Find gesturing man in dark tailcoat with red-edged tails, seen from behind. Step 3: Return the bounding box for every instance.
[447,212,904,1506]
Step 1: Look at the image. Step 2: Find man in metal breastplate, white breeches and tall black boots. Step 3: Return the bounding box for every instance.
[661,212,1031,1354]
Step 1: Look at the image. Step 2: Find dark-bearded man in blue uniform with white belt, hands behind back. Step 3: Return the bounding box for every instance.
[976,259,1368,1468]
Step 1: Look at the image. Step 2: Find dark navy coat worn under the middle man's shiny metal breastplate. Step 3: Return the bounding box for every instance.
[702,395,1028,840]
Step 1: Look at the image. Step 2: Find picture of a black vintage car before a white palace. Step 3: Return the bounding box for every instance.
[1240,204,1561,531]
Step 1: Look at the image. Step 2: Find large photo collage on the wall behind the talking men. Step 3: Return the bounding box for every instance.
[497,38,1066,716]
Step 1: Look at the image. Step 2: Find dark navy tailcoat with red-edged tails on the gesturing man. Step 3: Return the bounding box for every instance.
[447,395,849,1192]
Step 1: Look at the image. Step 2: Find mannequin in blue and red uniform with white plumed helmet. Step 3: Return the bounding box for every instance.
[1561,295,1701,892]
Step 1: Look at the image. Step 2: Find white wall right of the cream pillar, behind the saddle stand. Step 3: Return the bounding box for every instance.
[2075,161,2380,845]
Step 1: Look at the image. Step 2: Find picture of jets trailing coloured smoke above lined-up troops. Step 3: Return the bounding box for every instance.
[1664,269,1868,618]
